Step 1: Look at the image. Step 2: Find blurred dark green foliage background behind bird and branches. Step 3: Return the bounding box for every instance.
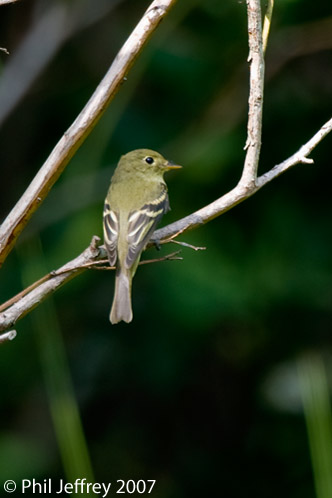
[0,0,332,498]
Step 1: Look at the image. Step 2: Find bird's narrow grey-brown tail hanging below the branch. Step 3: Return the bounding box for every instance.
[110,267,133,324]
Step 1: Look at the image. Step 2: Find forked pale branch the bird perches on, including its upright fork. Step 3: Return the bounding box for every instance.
[0,0,332,334]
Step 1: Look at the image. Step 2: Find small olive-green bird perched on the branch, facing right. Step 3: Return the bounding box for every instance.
[103,149,182,324]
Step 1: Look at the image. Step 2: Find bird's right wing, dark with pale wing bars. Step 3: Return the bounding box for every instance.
[125,185,169,268]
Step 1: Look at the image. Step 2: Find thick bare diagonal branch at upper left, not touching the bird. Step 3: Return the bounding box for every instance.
[0,0,176,266]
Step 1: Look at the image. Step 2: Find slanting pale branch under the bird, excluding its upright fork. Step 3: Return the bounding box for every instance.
[0,122,332,334]
